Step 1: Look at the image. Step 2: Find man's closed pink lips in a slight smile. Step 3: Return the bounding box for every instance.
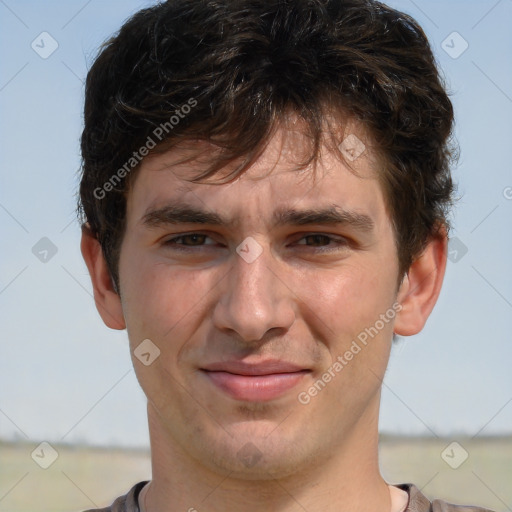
[201,360,310,402]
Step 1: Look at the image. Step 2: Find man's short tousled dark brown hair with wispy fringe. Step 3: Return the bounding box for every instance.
[79,0,456,287]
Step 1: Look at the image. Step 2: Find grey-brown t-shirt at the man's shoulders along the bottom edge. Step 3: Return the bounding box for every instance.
[84,482,492,512]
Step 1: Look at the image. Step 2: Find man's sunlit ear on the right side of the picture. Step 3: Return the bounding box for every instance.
[394,226,448,336]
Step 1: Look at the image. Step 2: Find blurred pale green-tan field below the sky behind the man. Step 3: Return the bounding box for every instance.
[0,437,512,512]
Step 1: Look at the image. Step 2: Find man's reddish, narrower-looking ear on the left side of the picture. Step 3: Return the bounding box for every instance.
[80,225,126,329]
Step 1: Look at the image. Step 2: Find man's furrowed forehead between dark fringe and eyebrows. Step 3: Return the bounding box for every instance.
[124,124,386,226]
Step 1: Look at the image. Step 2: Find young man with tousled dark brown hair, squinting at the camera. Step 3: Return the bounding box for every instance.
[80,0,492,512]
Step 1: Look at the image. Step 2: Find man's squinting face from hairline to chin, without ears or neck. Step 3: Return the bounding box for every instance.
[119,126,399,478]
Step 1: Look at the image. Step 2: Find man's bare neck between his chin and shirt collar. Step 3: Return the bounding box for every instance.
[142,396,392,512]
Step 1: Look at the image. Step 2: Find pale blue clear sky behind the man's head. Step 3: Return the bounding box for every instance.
[0,0,512,447]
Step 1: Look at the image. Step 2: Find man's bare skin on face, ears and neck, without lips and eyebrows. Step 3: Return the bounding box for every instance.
[82,124,447,512]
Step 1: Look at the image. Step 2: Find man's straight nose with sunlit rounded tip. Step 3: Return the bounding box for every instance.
[213,241,295,342]
